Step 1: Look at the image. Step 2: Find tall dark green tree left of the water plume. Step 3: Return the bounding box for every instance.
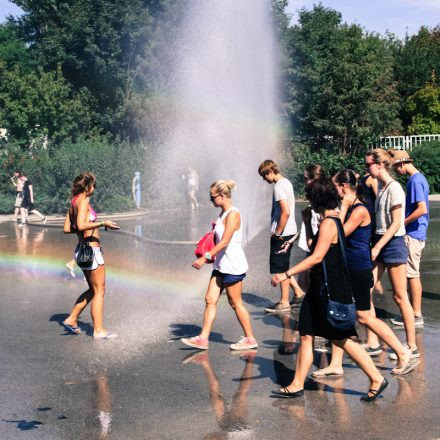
[10,0,158,134]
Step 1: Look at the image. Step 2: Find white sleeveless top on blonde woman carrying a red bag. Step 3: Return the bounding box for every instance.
[214,206,248,275]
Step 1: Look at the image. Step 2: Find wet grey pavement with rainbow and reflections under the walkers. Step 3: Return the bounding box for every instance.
[0,202,440,440]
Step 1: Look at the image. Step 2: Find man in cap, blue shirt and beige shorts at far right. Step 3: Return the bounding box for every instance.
[391,150,429,327]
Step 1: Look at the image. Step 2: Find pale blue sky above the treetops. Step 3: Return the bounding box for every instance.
[0,0,440,39]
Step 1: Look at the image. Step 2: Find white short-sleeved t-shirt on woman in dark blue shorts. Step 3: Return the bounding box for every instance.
[375,180,406,237]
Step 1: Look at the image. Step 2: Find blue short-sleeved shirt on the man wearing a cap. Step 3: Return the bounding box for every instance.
[405,172,429,240]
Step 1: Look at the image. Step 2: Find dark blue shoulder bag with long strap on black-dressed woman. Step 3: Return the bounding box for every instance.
[322,217,356,330]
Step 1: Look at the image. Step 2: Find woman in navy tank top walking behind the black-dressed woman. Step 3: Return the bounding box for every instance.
[312,170,415,377]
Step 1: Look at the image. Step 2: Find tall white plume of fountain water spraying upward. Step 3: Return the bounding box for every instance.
[160,0,280,240]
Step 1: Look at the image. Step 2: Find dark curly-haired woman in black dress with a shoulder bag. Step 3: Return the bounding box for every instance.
[272,178,388,402]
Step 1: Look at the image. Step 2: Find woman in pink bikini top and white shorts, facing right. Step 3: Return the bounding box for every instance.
[63,172,119,339]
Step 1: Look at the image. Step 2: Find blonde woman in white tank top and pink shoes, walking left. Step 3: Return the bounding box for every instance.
[181,180,258,350]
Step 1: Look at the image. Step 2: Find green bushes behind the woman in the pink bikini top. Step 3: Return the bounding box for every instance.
[0,137,140,214]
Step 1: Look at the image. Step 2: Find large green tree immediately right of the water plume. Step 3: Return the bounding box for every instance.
[286,5,400,155]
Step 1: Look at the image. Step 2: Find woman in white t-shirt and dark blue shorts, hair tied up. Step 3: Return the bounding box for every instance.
[365,148,420,359]
